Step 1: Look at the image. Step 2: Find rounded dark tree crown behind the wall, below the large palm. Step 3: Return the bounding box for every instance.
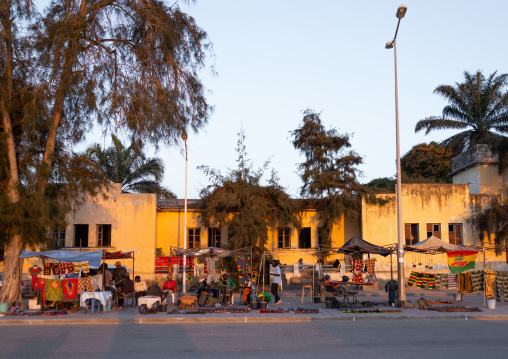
[400,142,452,183]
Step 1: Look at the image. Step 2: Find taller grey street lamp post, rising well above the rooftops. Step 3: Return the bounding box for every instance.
[385,5,407,302]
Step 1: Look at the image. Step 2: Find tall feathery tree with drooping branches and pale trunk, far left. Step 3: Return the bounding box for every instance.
[0,0,211,303]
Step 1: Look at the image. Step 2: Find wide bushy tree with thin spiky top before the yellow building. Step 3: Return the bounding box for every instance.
[199,130,300,258]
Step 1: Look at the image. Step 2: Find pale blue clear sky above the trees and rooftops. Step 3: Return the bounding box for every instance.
[32,0,508,198]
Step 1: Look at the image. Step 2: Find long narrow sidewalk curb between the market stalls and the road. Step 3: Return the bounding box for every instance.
[0,314,508,326]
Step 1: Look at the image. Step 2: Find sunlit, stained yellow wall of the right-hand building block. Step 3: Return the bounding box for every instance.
[362,184,508,277]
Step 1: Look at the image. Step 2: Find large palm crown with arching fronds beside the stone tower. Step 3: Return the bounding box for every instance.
[415,71,508,155]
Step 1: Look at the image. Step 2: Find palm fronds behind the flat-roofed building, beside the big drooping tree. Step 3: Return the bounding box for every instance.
[85,135,176,198]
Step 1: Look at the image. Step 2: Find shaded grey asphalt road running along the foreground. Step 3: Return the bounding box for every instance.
[0,320,508,359]
